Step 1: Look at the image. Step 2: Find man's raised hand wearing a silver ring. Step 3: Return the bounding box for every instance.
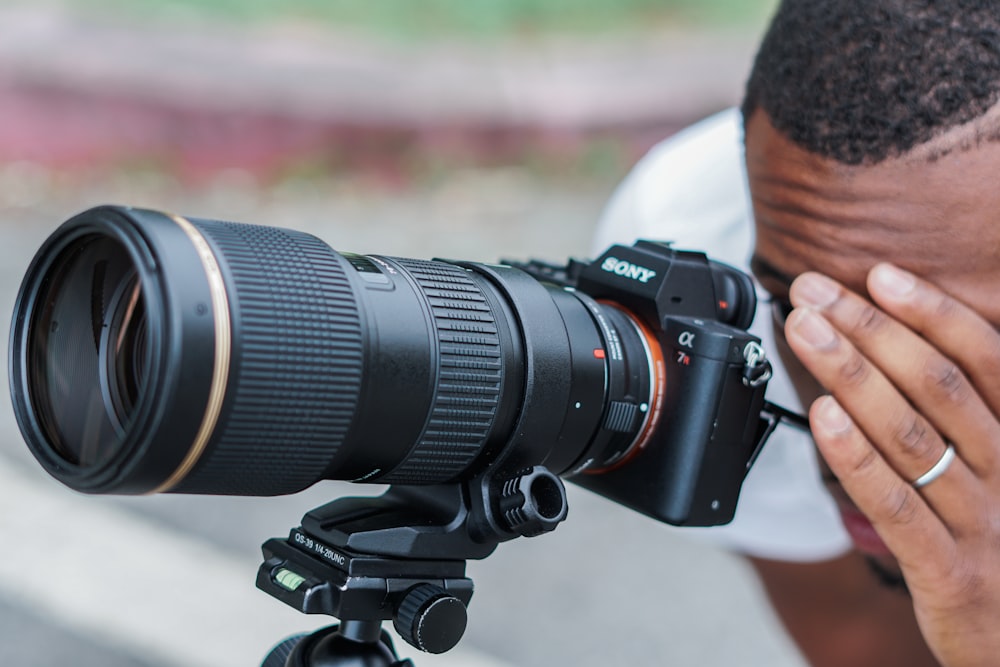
[785,264,1000,667]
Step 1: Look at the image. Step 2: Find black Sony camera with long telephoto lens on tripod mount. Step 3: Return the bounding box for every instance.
[9,206,796,664]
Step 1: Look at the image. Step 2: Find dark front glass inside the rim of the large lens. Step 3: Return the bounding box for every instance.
[27,234,149,466]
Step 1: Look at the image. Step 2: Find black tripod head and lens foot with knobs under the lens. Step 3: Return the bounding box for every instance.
[257,466,567,667]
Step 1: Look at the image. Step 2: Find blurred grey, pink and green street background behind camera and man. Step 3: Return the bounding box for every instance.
[0,0,801,667]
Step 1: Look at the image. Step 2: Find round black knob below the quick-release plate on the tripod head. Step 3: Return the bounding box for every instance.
[392,584,468,653]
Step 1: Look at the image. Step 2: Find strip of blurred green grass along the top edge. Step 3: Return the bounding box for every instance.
[91,0,777,41]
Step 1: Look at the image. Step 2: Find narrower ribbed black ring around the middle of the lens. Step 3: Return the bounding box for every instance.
[379,259,503,484]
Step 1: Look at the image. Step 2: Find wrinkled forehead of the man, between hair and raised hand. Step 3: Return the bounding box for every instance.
[746,113,1000,288]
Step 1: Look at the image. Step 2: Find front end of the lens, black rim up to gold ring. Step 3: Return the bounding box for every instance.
[9,206,229,494]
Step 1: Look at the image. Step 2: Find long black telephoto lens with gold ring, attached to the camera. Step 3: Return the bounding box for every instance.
[10,206,663,495]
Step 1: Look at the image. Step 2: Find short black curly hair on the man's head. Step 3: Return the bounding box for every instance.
[742,0,1000,164]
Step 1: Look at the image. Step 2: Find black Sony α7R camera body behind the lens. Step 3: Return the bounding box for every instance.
[526,241,771,526]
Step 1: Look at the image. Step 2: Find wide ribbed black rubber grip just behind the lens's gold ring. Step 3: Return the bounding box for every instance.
[174,220,362,495]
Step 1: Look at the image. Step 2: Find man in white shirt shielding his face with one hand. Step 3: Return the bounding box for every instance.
[600,0,1000,667]
